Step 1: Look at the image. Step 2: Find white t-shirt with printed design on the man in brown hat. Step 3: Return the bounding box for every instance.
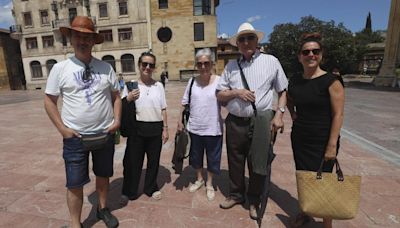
[45,56,119,134]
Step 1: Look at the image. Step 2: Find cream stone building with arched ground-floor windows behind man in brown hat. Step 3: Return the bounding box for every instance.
[10,0,150,89]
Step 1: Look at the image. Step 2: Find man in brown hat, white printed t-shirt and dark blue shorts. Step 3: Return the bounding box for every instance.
[44,16,121,228]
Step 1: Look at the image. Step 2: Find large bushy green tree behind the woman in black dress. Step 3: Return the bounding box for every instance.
[268,16,357,77]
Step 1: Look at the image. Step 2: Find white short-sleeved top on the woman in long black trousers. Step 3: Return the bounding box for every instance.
[122,82,167,122]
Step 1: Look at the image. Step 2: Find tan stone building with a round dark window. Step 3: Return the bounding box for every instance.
[150,0,219,80]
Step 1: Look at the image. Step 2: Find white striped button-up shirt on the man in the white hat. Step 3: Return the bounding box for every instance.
[217,51,288,117]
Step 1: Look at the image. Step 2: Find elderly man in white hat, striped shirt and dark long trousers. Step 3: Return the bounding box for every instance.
[217,23,288,219]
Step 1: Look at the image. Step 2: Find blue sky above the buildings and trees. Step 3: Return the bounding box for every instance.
[0,0,391,42]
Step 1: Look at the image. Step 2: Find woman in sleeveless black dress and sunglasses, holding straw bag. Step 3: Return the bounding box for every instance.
[288,33,344,227]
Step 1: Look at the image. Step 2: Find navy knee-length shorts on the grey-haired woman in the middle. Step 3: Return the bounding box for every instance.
[189,132,222,175]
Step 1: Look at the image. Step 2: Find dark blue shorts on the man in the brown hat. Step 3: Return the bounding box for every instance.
[63,137,115,189]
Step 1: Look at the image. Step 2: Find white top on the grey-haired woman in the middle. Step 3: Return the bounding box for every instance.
[182,76,223,136]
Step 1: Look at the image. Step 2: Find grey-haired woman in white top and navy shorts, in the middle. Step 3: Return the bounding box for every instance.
[178,48,223,201]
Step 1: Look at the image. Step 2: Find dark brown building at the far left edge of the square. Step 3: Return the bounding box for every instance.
[0,29,25,90]
